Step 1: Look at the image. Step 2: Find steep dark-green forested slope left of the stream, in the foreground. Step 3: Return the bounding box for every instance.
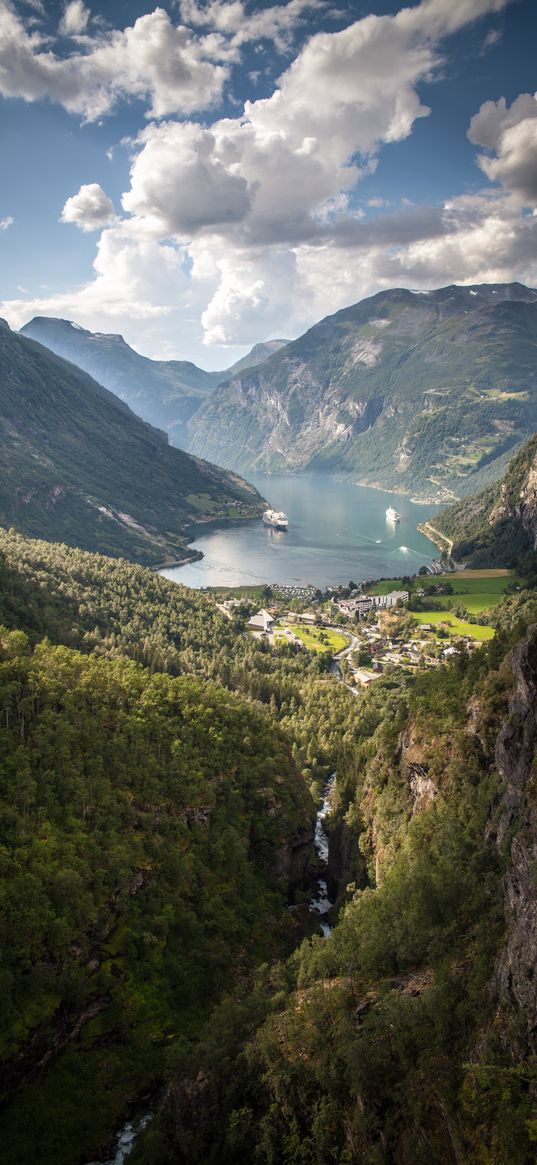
[0,628,313,1165]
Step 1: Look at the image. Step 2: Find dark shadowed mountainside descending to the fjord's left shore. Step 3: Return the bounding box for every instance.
[0,323,261,563]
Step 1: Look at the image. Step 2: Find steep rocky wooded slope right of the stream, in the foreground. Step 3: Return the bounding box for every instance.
[135,602,537,1165]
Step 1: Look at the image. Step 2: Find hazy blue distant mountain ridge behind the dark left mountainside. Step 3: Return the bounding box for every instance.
[21,316,219,447]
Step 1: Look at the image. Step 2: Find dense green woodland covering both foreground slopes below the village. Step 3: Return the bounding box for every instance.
[0,532,537,1165]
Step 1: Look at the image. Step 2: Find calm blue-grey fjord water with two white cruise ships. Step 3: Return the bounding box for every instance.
[162,474,438,587]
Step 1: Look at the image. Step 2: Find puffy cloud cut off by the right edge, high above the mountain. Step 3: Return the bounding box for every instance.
[468,93,537,206]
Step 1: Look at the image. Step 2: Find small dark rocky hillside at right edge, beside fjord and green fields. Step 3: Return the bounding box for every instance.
[433,435,537,566]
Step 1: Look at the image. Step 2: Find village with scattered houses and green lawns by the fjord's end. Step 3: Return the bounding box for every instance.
[212,571,503,691]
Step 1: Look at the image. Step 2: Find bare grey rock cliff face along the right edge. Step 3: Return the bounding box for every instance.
[494,627,537,1054]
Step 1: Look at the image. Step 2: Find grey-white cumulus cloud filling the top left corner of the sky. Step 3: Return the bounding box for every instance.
[0,0,228,121]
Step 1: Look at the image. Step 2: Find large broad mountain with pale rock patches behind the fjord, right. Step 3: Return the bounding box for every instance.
[189,283,537,497]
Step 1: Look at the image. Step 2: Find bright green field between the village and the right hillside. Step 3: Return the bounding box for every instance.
[370,570,520,623]
